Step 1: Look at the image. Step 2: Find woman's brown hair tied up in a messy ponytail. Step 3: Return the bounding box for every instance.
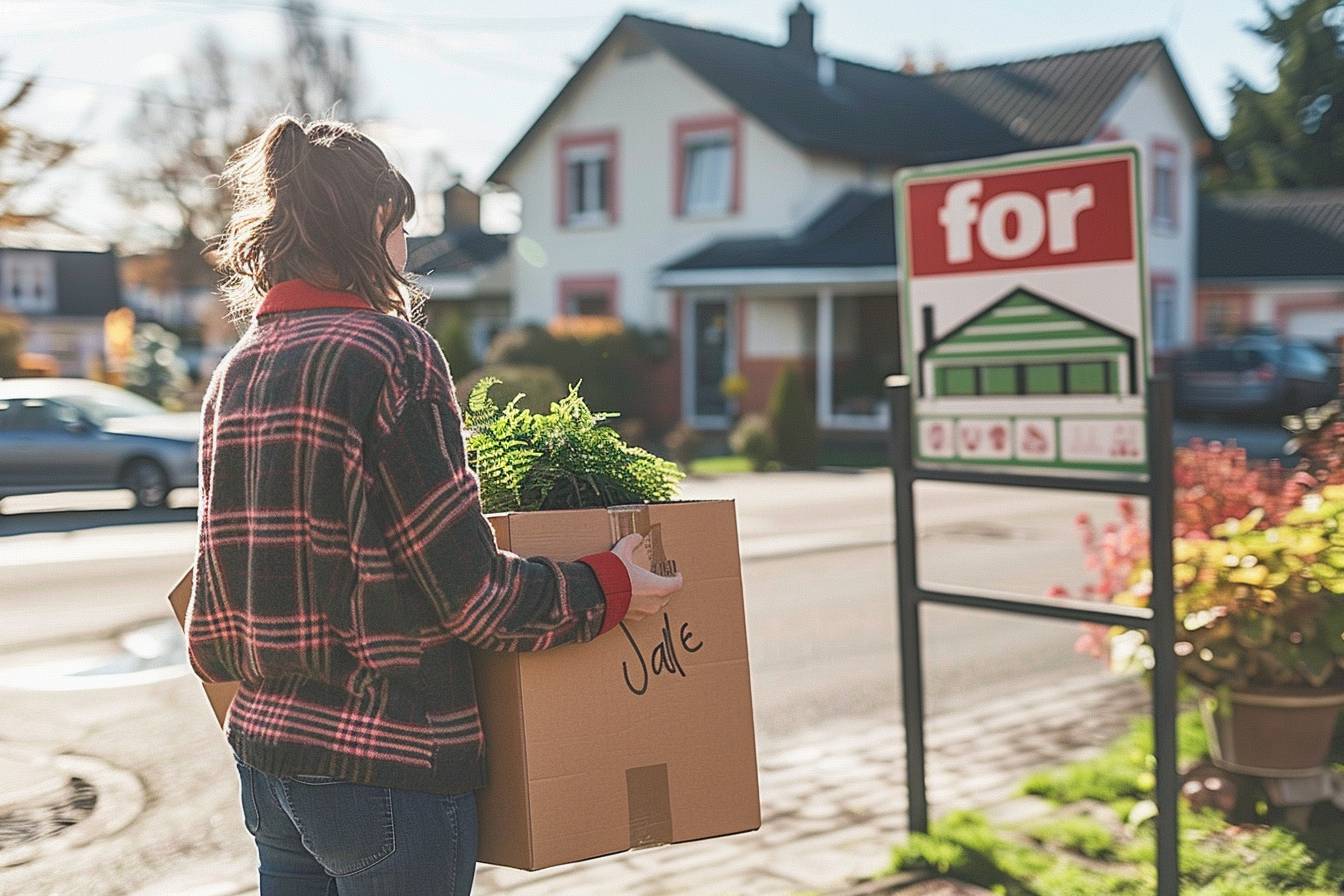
[215,116,425,320]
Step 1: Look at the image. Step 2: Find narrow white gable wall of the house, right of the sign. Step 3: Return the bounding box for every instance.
[1102,63,1203,348]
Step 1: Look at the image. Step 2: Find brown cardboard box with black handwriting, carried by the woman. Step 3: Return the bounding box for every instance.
[162,501,761,870]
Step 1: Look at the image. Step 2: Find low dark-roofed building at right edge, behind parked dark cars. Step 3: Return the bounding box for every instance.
[1195,189,1344,344]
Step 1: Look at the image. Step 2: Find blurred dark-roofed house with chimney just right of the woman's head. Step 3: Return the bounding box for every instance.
[406,183,511,359]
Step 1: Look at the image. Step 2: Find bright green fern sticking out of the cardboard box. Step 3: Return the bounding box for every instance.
[464,376,683,513]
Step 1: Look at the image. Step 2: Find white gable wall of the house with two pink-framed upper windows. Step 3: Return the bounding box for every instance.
[507,36,863,326]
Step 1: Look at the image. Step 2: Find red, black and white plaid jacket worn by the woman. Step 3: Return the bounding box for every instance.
[187,281,630,794]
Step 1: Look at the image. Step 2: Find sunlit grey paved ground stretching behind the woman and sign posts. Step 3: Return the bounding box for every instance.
[0,473,1141,896]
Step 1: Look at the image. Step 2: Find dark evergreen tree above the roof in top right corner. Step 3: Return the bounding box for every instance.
[1214,0,1344,189]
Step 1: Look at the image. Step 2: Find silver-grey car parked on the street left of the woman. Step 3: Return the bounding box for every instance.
[0,379,200,506]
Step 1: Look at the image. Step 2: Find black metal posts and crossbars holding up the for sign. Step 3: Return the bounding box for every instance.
[887,376,1180,896]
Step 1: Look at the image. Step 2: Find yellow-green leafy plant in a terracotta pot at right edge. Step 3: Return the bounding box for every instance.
[1111,485,1344,778]
